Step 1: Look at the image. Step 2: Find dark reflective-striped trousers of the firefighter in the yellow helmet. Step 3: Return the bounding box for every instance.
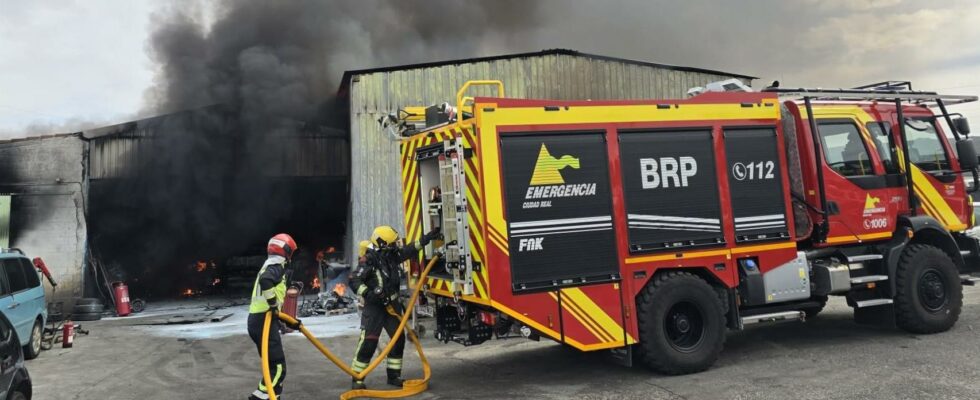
[351,303,405,377]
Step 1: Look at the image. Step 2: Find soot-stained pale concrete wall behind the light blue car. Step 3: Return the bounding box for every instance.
[0,135,87,300]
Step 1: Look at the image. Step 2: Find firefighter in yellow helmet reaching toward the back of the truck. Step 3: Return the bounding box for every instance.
[350,226,440,389]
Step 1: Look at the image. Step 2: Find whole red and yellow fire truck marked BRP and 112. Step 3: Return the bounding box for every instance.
[386,81,980,374]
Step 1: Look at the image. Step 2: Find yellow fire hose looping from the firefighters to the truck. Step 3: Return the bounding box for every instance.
[262,256,439,400]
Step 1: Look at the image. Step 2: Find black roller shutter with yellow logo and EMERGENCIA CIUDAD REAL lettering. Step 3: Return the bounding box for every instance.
[500,132,619,292]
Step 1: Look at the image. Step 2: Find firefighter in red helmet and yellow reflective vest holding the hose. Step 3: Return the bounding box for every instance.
[248,233,296,400]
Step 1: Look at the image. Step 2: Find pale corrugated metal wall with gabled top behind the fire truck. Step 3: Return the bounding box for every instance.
[348,54,748,254]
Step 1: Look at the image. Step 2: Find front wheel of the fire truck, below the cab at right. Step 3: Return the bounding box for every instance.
[895,244,963,333]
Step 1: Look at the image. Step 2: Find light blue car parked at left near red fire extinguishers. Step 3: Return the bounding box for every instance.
[0,249,48,360]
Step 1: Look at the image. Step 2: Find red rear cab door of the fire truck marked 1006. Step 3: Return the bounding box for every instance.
[817,117,905,244]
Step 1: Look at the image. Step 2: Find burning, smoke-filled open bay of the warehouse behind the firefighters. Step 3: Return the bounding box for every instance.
[86,107,349,298]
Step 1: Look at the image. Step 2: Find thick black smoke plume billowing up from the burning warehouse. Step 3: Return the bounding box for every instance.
[89,0,537,295]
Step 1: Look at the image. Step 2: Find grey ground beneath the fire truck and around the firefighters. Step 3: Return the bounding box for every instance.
[28,287,980,400]
